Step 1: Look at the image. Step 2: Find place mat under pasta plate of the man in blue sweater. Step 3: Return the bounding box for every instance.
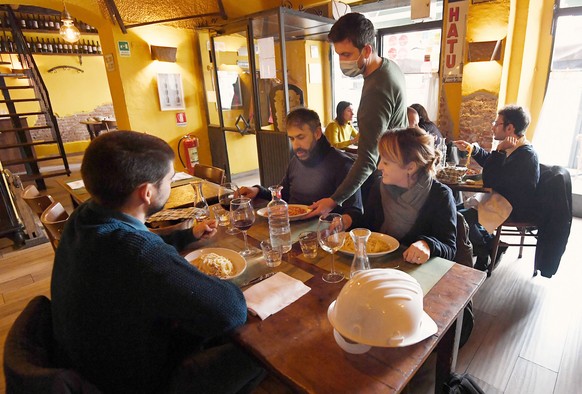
[189,230,313,286]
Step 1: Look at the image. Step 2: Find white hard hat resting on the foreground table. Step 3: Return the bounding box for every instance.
[327,268,437,353]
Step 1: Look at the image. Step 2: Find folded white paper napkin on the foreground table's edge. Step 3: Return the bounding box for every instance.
[243,272,311,320]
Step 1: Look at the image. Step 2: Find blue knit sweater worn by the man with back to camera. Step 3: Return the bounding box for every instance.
[51,201,247,393]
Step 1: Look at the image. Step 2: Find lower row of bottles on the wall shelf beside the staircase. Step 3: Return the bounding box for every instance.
[0,35,102,56]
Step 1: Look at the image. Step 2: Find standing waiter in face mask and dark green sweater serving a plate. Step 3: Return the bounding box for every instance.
[309,13,408,217]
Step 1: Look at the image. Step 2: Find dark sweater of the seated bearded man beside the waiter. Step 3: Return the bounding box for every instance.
[256,135,362,215]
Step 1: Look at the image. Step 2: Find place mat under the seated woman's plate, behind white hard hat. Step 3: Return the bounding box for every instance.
[306,248,455,294]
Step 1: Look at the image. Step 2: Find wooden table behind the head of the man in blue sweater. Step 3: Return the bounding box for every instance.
[57,177,220,209]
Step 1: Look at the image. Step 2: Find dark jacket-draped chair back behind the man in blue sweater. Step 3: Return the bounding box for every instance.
[4,295,101,394]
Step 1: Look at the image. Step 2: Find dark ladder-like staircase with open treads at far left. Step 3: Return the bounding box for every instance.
[0,5,71,190]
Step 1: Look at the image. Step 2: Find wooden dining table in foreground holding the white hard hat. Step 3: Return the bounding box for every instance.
[190,212,485,393]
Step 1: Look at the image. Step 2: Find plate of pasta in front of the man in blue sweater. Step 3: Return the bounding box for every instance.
[184,248,247,279]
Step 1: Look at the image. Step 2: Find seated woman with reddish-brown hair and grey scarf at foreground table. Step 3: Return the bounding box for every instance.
[346,127,457,264]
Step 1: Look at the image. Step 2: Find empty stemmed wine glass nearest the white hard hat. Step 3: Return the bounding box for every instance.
[317,213,346,283]
